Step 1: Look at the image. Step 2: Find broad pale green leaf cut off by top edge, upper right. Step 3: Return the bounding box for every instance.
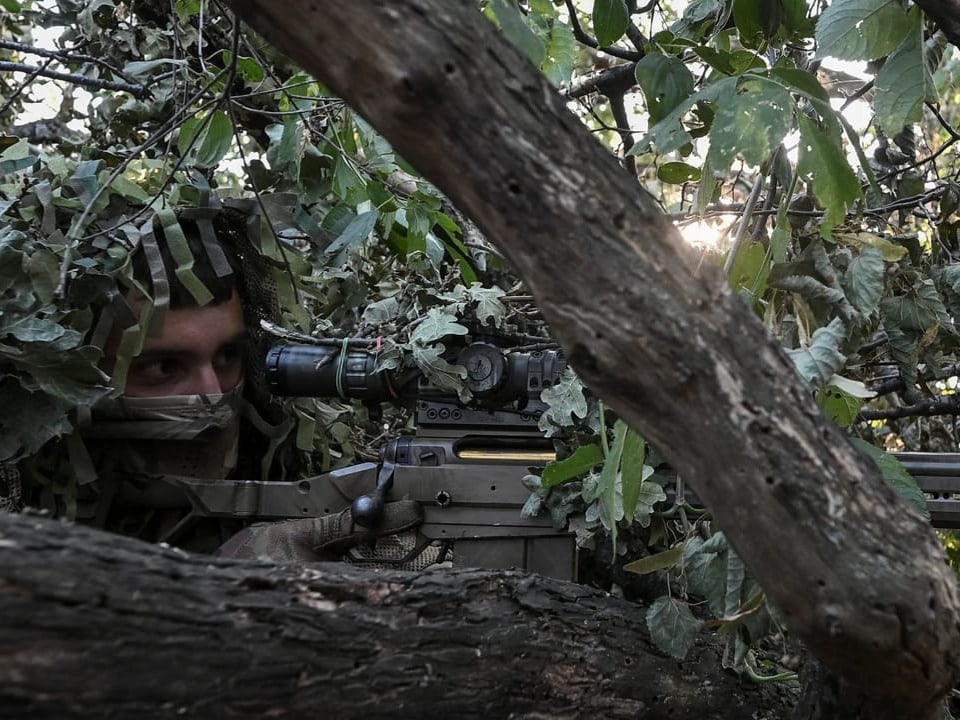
[816,0,911,60]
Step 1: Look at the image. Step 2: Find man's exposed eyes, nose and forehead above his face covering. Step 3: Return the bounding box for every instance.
[124,292,245,397]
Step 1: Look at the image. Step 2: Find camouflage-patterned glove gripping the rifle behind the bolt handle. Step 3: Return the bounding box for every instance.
[215,500,423,567]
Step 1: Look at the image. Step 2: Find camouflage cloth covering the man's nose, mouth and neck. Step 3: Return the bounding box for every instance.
[81,386,242,509]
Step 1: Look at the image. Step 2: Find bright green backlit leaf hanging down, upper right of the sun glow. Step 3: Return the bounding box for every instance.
[797,114,862,233]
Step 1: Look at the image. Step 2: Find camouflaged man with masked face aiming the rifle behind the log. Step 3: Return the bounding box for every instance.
[10,201,437,569]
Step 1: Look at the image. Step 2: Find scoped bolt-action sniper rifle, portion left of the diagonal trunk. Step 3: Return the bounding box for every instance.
[177,342,576,580]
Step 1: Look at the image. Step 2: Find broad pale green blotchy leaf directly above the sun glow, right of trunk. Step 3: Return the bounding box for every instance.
[710,78,794,169]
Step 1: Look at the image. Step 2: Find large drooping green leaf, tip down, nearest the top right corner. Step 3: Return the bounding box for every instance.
[873,7,937,135]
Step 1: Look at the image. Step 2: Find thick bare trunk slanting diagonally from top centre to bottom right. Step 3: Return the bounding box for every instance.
[225,0,960,719]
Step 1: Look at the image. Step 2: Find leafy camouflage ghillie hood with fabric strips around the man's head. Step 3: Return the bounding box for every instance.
[0,181,312,528]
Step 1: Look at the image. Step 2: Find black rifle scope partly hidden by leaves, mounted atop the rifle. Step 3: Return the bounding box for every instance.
[266,342,567,402]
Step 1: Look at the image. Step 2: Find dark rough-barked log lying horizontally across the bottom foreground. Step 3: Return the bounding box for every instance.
[0,515,791,720]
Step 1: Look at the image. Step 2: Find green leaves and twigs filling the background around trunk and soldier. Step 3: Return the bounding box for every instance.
[0,0,960,688]
